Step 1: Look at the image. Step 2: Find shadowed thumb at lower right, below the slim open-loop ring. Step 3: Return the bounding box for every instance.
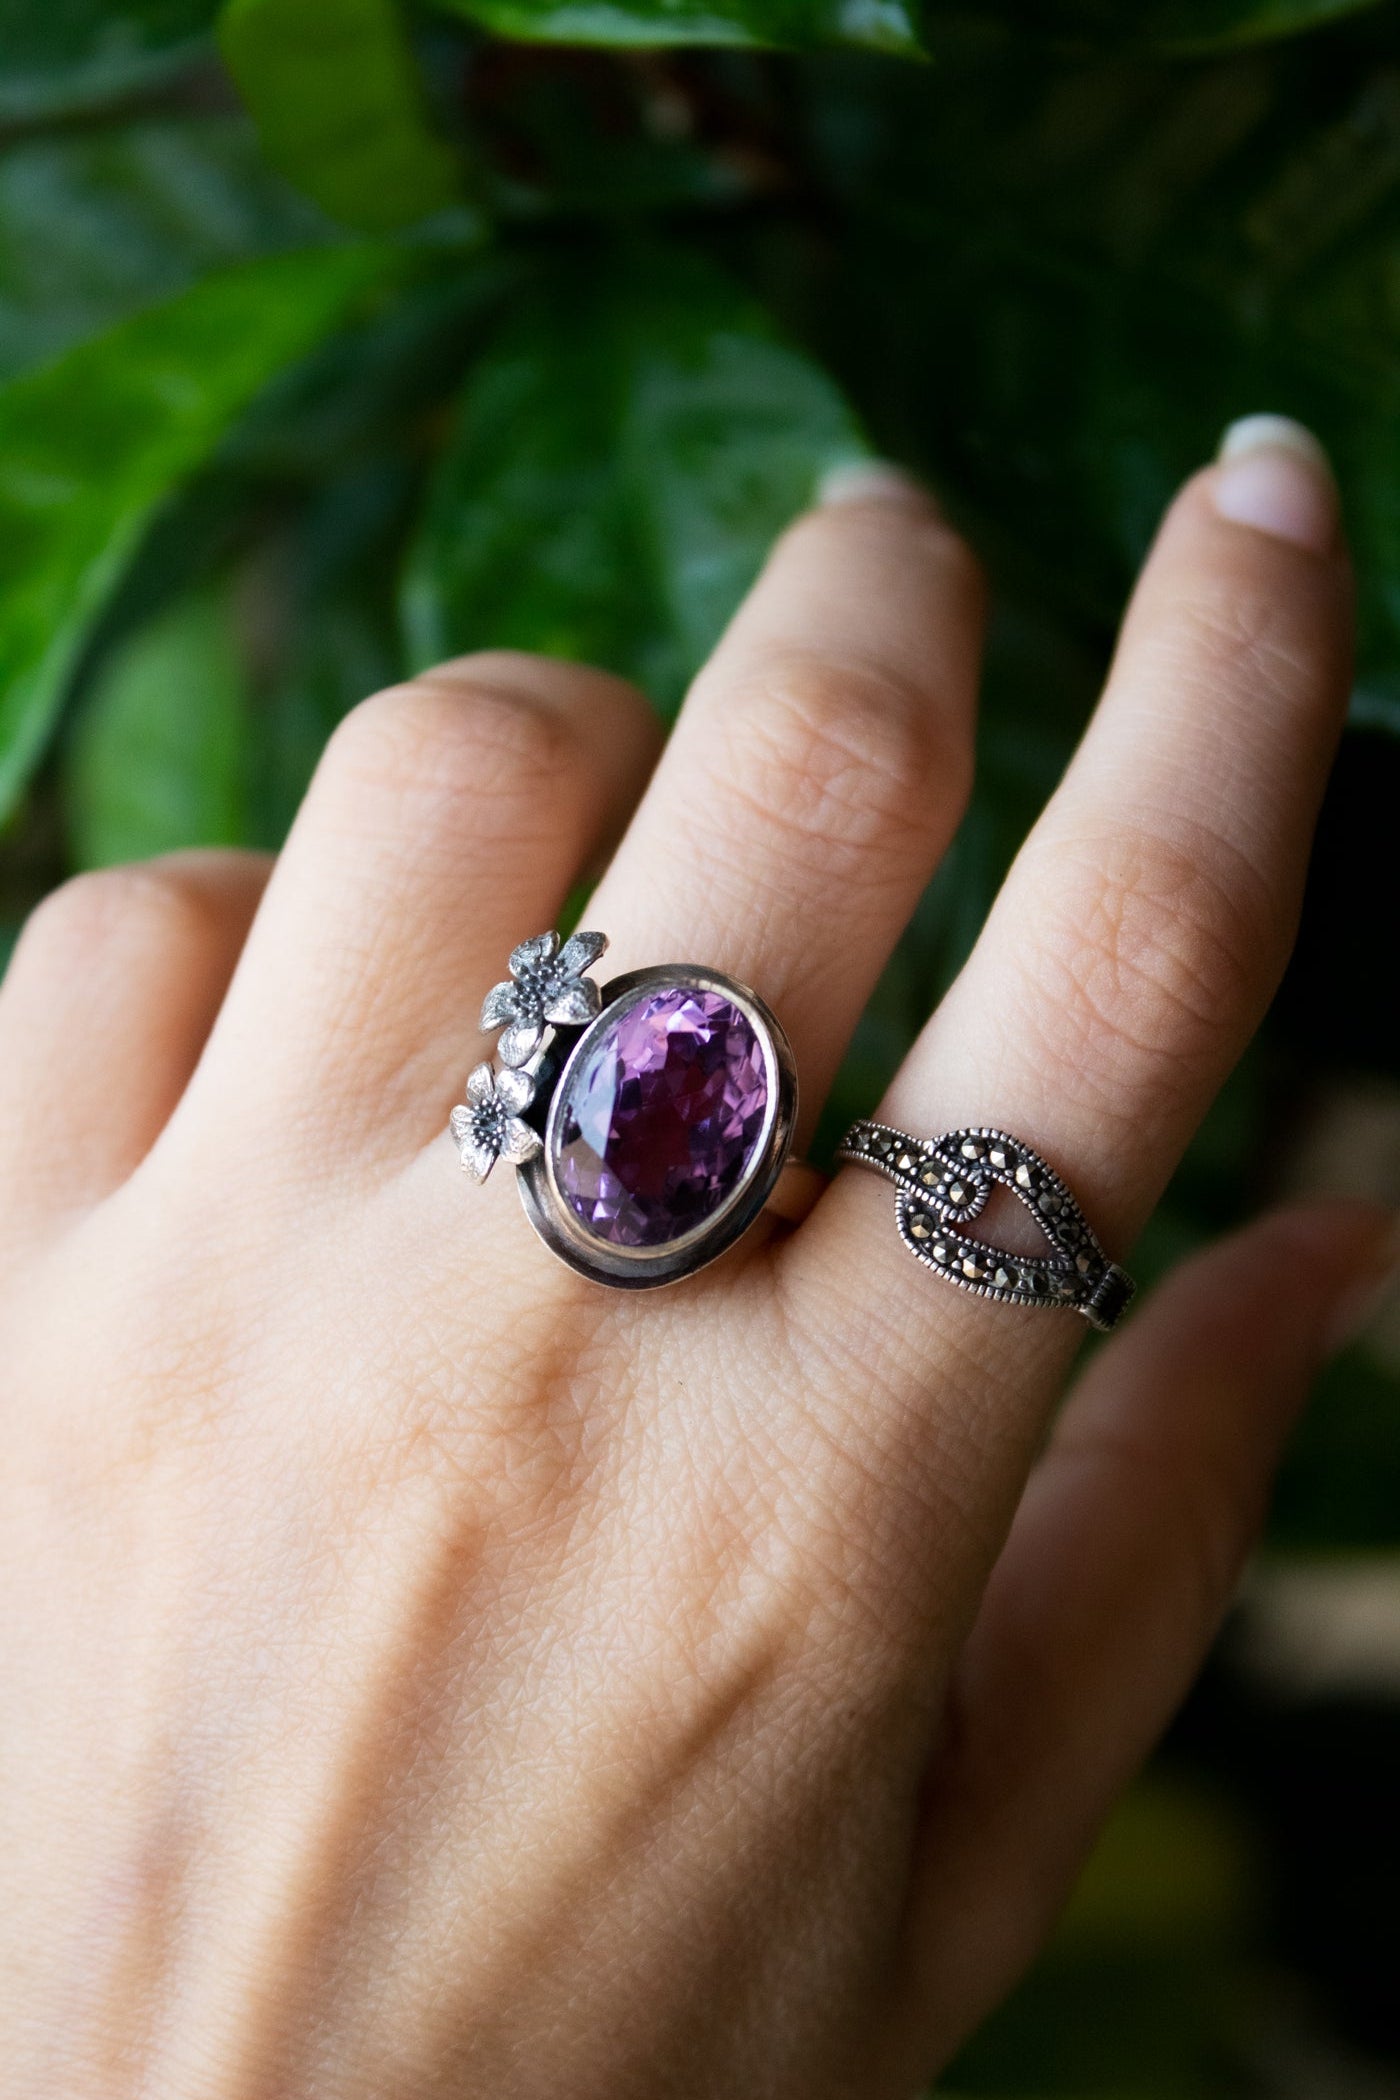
[913,1203,1396,2056]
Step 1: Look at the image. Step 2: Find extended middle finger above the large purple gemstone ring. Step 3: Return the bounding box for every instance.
[590,468,982,1119]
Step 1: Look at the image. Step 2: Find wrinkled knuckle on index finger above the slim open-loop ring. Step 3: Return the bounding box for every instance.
[1020,830,1280,1108]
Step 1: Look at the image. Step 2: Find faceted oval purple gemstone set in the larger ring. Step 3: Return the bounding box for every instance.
[556,985,768,1247]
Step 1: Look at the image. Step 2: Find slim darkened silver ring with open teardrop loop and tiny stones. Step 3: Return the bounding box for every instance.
[839,1124,1138,1334]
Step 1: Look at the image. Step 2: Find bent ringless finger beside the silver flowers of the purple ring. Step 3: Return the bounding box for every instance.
[183,651,659,1166]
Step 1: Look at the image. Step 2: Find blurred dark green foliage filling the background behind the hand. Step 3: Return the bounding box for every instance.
[0,0,1400,2096]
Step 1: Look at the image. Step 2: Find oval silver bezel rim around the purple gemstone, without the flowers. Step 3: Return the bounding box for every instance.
[518,962,798,1292]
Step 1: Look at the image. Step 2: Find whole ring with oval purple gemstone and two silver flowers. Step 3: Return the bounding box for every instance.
[451,932,797,1289]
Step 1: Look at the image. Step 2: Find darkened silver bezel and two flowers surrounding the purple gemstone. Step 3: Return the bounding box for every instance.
[451,932,798,1289]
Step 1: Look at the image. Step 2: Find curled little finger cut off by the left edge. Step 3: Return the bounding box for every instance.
[0,851,271,1233]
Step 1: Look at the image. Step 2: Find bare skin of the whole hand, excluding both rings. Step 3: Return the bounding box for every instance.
[0,434,1387,2100]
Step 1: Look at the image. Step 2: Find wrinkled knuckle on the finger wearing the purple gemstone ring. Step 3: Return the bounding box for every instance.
[714,653,970,880]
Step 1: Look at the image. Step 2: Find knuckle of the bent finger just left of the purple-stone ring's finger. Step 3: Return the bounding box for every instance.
[321,659,577,832]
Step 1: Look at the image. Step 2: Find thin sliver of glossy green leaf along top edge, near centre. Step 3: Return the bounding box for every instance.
[437,0,924,57]
